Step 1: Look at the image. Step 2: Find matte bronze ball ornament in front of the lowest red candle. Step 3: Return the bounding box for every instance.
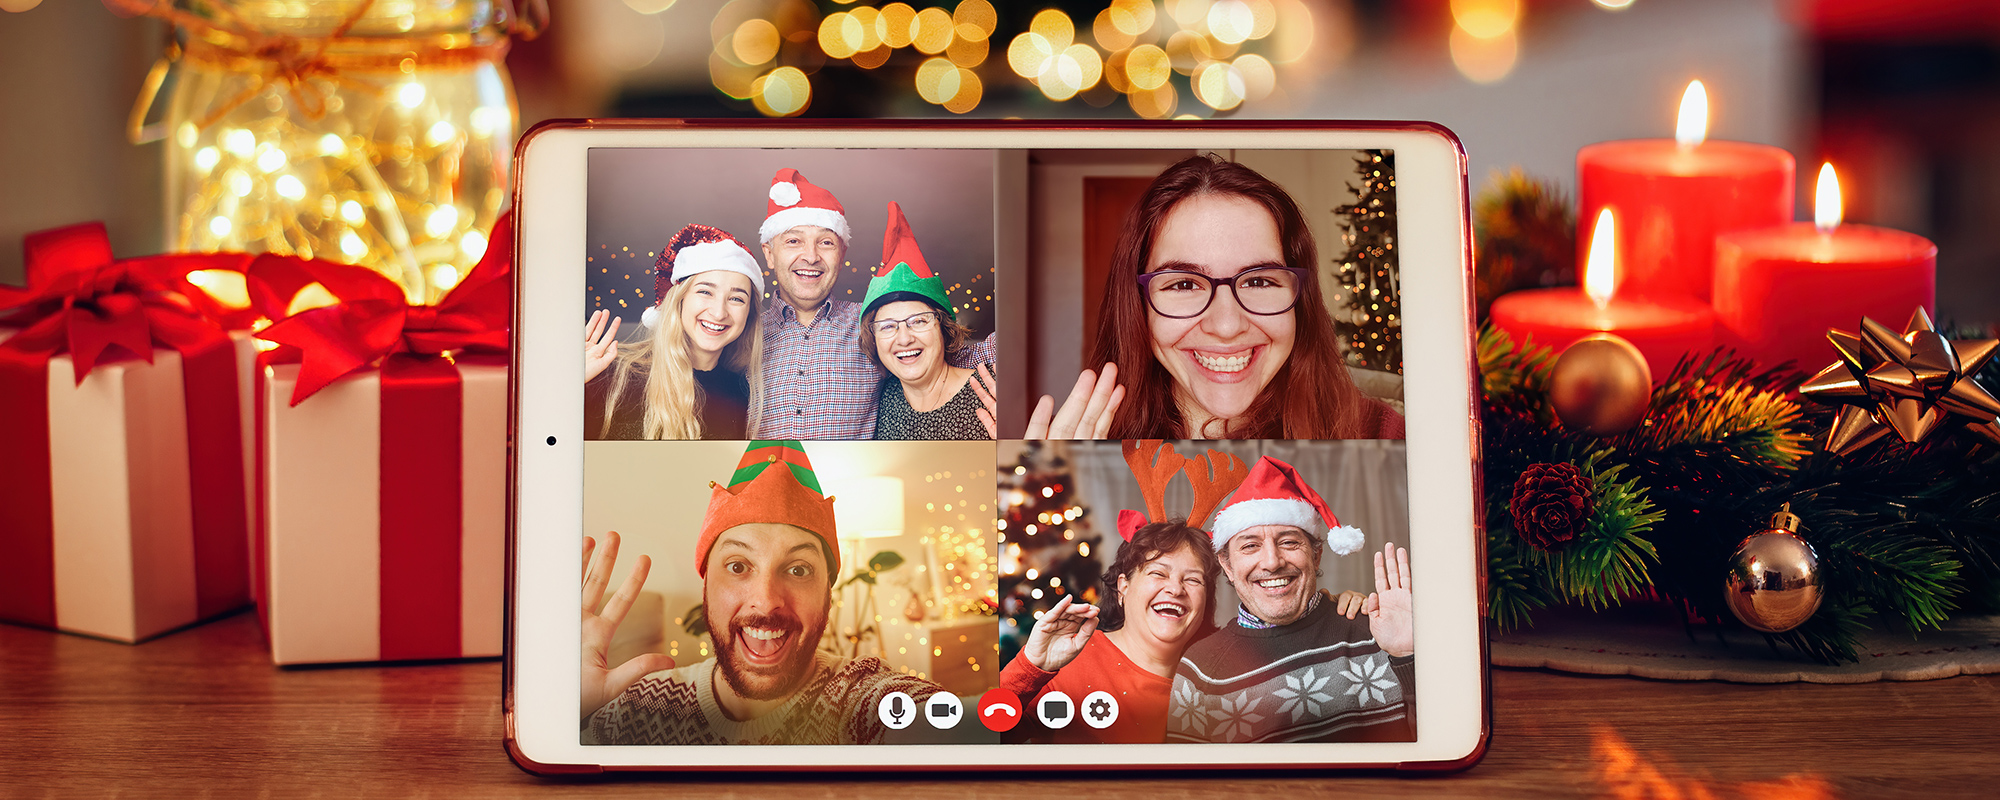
[1548,334,1652,436]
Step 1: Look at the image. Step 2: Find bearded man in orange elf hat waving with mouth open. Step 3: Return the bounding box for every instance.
[582,442,940,744]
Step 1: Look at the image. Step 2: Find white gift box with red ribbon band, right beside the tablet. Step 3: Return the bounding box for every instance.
[256,356,508,664]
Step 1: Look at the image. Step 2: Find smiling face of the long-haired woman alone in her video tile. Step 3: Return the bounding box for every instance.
[1146,194,1296,436]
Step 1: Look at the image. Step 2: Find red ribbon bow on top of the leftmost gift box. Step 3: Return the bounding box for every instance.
[0,222,252,384]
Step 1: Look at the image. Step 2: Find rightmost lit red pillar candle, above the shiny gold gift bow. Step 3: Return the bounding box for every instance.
[1714,164,1938,374]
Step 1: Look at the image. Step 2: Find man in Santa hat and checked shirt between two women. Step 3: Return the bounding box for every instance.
[756,168,994,440]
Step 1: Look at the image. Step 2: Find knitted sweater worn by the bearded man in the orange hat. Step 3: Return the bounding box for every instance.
[582,652,938,744]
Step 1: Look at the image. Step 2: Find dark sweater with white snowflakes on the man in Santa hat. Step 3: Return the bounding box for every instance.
[1166,602,1416,742]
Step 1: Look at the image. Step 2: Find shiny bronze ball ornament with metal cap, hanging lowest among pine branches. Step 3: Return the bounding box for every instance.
[1722,504,1826,634]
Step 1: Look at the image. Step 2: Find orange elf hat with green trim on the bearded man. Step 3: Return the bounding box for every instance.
[694,442,840,578]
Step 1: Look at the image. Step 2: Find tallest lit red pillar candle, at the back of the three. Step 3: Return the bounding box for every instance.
[1576,80,1796,300]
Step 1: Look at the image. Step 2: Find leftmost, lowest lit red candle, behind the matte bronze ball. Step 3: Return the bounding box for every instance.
[1492,210,1716,382]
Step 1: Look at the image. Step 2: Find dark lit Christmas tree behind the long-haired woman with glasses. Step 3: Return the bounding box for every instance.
[1334,150,1402,374]
